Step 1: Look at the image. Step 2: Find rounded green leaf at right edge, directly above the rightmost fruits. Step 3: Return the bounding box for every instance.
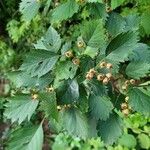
[126,61,150,79]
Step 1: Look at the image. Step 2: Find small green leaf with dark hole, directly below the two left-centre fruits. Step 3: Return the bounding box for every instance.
[55,61,78,80]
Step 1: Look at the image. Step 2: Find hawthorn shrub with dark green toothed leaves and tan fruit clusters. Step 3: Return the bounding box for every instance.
[0,0,150,150]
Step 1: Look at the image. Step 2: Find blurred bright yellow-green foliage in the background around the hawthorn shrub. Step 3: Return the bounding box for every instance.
[0,0,150,150]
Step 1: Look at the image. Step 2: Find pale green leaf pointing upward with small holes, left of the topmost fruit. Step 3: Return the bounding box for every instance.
[34,26,61,53]
